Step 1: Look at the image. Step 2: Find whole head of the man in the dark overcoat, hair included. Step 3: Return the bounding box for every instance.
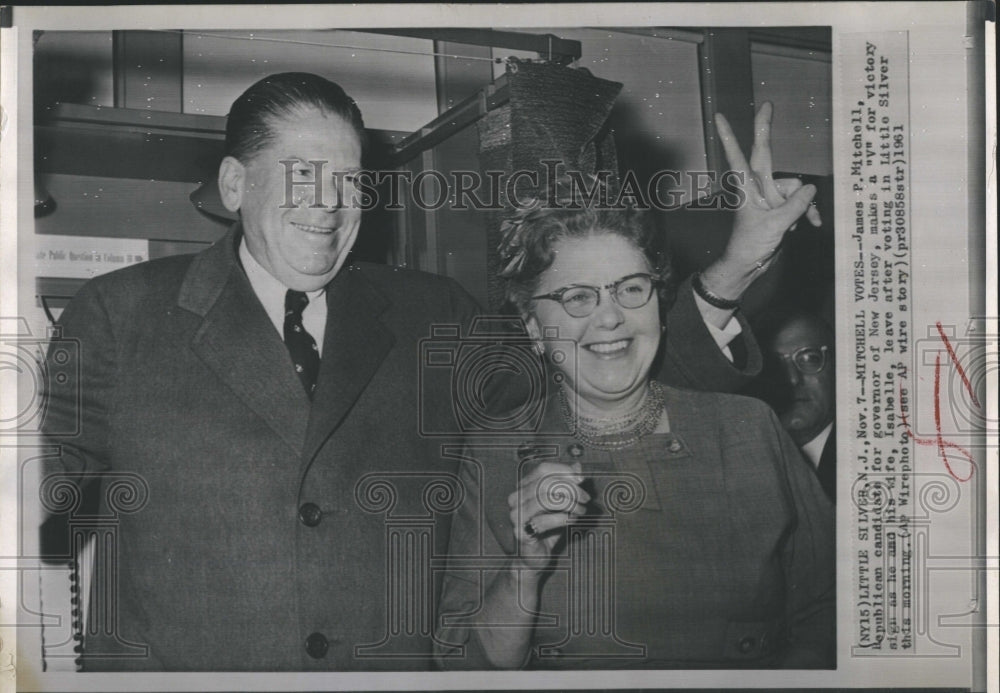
[219,80,365,291]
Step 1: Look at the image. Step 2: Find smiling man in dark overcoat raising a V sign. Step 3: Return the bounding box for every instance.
[45,73,808,671]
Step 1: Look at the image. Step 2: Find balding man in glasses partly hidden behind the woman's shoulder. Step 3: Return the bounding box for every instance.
[768,312,837,501]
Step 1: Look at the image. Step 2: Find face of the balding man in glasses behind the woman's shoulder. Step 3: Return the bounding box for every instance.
[771,318,836,445]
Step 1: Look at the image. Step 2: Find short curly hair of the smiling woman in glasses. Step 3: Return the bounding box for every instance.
[498,177,674,316]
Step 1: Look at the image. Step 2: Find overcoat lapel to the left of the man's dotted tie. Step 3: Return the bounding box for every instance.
[178,227,309,454]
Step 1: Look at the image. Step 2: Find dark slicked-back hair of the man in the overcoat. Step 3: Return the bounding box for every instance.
[225,72,366,163]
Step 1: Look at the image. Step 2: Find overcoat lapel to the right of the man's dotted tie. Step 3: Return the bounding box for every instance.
[299,266,396,463]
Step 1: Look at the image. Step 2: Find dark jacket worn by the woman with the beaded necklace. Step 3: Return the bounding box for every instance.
[438,388,836,669]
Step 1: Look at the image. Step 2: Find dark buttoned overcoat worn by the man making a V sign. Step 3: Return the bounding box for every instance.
[37,227,756,671]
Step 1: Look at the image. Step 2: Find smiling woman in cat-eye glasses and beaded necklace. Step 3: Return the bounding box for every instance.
[437,172,835,669]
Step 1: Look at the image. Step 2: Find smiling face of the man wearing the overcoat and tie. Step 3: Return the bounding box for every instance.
[239,107,361,291]
